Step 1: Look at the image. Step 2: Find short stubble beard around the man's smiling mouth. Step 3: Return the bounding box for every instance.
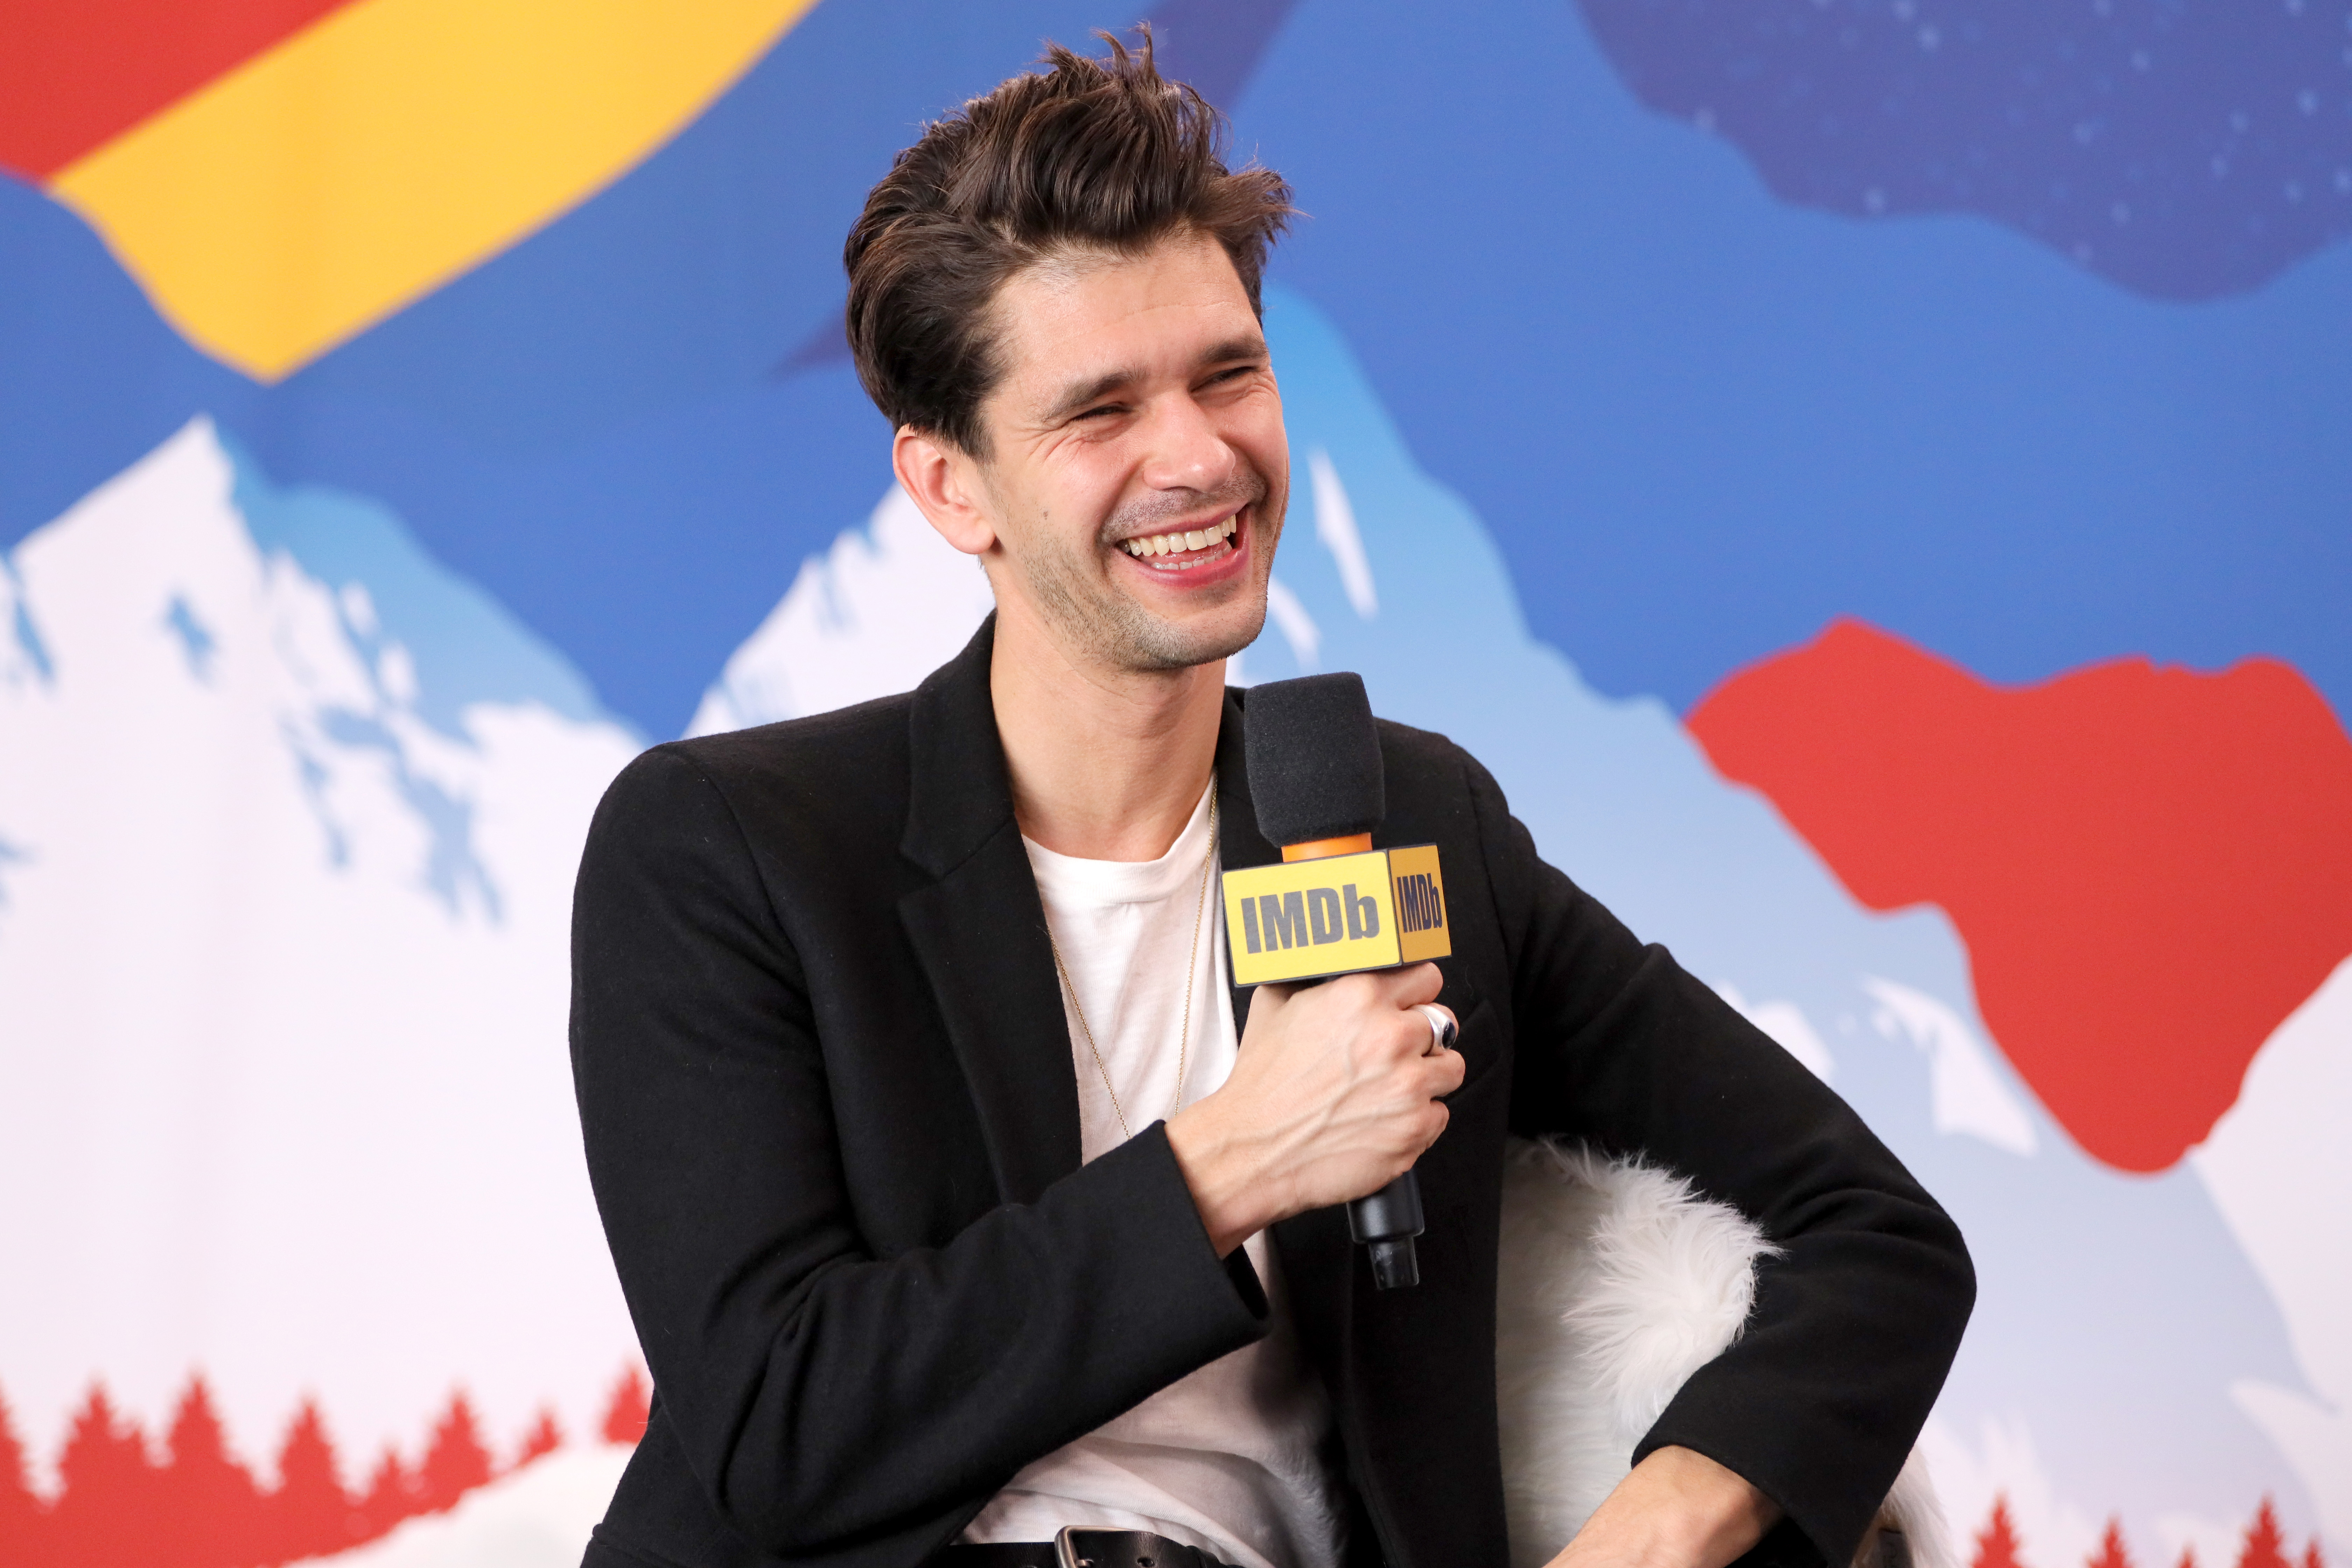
[1023,472,1282,670]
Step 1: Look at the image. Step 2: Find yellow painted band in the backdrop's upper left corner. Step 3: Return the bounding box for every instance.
[49,0,814,381]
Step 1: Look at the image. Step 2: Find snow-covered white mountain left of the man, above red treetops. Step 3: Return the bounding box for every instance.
[0,421,640,1486]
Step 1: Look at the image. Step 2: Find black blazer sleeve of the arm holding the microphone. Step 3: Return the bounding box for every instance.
[572,750,1265,1559]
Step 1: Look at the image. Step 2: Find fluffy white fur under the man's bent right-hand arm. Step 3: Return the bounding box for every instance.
[1496,1140,1957,1568]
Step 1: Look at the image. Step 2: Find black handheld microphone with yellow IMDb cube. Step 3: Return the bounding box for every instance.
[1221,670,1454,1290]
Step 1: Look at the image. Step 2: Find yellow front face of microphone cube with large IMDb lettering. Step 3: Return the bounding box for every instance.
[1221,849,1435,985]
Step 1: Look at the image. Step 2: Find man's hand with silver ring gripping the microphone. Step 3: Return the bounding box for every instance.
[1169,964,1463,1258]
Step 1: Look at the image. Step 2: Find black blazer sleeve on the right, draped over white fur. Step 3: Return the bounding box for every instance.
[1470,762,1976,1563]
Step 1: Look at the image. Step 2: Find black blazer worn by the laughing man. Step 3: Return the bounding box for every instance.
[572,621,1973,1568]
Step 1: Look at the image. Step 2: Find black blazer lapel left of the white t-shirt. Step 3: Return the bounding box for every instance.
[898,616,1079,1204]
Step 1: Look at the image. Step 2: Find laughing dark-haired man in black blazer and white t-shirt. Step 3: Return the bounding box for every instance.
[574,42,1973,1568]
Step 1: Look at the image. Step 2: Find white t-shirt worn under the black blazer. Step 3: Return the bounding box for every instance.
[962,794,1340,1568]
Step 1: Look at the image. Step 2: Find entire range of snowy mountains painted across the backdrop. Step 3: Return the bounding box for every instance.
[0,289,2352,1568]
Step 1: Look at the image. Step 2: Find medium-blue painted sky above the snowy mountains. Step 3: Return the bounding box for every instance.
[0,0,2352,736]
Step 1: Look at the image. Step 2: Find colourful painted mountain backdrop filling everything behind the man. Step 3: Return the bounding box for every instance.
[0,0,2352,1568]
